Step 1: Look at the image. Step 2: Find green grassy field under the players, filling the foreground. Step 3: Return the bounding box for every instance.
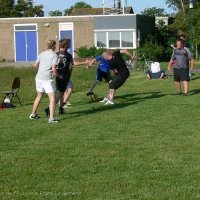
[0,68,200,200]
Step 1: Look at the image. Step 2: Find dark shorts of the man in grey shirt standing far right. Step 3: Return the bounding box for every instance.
[174,68,190,82]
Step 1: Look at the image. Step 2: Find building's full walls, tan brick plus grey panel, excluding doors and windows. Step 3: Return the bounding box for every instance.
[0,15,155,61]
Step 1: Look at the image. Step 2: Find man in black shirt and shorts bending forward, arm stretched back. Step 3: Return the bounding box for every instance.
[104,50,130,105]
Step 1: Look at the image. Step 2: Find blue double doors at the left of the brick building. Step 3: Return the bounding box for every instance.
[15,31,37,61]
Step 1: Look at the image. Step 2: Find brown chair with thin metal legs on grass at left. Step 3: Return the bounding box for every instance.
[1,77,22,106]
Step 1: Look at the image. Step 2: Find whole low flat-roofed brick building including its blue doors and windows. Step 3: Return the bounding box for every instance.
[0,14,155,62]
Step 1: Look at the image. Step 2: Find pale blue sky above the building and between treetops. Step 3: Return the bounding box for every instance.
[34,0,173,16]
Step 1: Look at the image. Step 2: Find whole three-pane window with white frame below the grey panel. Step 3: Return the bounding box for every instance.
[95,30,137,49]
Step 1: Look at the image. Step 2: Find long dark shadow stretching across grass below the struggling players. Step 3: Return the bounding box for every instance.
[61,92,165,120]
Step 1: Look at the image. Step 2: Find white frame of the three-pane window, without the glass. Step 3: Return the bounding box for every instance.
[94,29,137,49]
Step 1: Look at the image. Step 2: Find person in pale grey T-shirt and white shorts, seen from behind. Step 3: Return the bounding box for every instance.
[29,40,58,123]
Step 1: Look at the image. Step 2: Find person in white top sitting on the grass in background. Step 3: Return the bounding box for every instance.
[145,58,166,79]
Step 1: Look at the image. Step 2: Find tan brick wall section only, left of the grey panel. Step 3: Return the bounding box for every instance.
[0,17,94,61]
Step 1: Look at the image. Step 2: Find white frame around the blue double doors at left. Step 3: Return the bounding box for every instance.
[13,23,39,62]
